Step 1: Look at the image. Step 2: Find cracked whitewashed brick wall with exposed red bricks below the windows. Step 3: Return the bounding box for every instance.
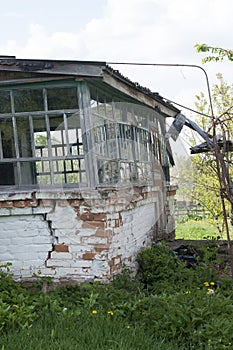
[0,187,175,282]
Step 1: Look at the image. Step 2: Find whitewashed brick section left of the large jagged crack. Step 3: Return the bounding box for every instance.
[0,210,52,278]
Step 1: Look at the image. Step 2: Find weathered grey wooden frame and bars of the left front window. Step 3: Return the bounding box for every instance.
[0,80,87,192]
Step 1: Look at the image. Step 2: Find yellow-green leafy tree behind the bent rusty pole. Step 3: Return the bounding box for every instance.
[182,74,233,234]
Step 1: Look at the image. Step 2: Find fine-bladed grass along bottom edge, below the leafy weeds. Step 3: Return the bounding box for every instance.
[0,313,182,350]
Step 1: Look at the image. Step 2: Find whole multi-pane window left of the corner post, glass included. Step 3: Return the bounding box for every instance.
[0,82,86,186]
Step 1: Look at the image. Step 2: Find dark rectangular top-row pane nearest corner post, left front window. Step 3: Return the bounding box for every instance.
[47,87,78,110]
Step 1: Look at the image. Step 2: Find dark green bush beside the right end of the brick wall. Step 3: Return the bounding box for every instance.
[137,244,218,294]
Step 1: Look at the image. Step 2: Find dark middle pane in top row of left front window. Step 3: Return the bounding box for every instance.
[13,89,44,112]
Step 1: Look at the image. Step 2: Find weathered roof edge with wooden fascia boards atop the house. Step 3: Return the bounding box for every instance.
[0,56,180,117]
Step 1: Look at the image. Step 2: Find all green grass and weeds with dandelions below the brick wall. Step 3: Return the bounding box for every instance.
[0,243,233,350]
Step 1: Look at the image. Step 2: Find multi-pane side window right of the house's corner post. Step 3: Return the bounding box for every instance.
[90,86,166,187]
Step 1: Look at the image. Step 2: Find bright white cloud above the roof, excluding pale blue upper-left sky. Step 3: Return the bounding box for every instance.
[0,0,233,112]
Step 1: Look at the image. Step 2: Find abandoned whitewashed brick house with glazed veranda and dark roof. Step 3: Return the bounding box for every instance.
[0,56,180,281]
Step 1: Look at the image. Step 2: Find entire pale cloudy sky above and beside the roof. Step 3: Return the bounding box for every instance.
[0,0,233,119]
